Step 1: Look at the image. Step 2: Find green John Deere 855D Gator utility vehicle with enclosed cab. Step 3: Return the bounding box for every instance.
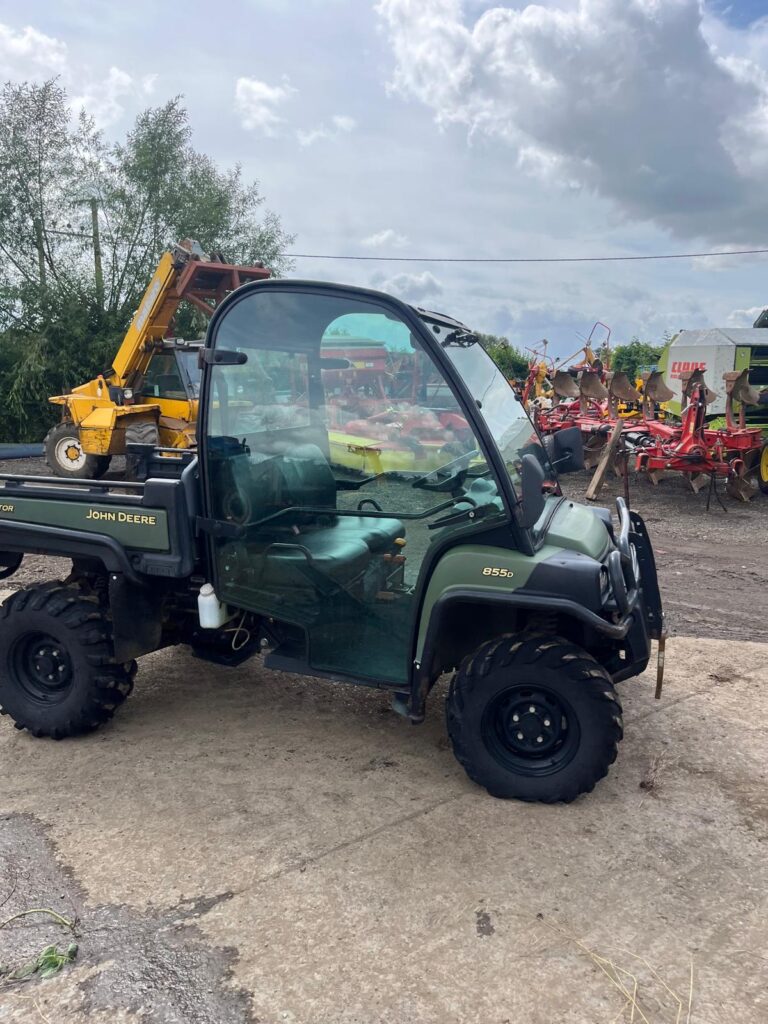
[0,281,663,802]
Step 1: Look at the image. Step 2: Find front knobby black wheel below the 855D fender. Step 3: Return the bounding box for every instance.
[446,634,624,804]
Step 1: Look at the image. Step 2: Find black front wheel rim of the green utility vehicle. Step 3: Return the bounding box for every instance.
[480,685,580,775]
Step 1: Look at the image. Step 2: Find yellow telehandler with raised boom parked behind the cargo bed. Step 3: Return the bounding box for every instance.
[45,240,269,479]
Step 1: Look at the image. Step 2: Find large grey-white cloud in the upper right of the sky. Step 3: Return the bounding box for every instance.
[377,0,768,241]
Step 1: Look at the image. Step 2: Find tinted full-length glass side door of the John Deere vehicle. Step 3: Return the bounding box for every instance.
[204,288,506,683]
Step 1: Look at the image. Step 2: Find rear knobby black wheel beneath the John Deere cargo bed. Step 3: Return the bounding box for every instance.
[0,583,136,739]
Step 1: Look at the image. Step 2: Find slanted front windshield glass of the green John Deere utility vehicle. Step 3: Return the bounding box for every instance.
[425,319,555,494]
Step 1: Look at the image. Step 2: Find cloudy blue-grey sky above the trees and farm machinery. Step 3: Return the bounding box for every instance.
[0,0,768,354]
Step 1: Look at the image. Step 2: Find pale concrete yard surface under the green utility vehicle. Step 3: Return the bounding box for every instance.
[0,637,768,1024]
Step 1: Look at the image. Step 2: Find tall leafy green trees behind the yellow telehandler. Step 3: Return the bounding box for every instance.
[0,81,292,441]
